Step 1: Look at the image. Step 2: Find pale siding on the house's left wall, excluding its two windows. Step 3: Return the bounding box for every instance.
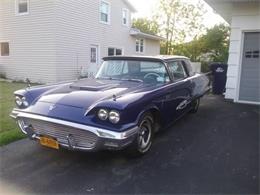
[0,0,56,82]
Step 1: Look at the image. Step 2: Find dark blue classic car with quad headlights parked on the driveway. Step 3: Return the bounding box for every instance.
[11,56,209,154]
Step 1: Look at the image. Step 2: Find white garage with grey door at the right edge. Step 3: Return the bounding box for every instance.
[206,0,260,104]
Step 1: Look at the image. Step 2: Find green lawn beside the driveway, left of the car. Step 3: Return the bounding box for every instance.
[0,81,26,146]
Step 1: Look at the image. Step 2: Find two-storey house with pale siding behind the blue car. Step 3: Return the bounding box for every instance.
[0,0,165,83]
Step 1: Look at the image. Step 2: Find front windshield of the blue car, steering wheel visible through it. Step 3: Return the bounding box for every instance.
[96,60,170,83]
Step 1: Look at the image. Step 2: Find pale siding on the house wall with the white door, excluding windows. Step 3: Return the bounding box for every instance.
[56,0,160,80]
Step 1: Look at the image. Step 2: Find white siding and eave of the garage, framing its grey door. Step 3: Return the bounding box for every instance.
[226,2,260,101]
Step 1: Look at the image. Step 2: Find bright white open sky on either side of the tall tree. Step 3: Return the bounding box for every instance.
[129,0,225,28]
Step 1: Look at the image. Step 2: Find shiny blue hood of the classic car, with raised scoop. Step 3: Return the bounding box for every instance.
[38,79,153,108]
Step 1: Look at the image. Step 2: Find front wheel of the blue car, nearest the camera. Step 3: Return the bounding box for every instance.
[128,113,154,155]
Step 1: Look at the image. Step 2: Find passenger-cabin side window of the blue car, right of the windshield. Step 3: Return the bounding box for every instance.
[168,61,187,80]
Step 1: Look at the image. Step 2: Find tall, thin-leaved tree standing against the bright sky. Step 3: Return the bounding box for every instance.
[156,0,205,54]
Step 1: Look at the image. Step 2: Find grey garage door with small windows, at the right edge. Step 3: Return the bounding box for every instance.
[239,32,260,103]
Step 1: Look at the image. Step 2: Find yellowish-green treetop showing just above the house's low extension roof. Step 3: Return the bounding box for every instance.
[132,18,160,35]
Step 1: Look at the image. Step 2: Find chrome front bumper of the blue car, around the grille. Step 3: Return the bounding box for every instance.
[10,109,139,151]
